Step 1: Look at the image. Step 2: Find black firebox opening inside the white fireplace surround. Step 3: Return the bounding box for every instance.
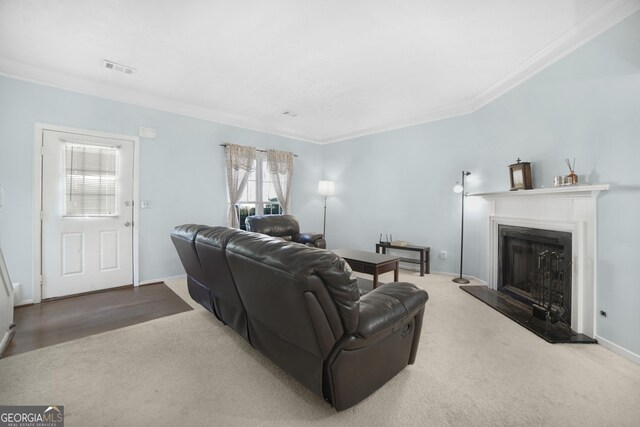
[497,224,572,327]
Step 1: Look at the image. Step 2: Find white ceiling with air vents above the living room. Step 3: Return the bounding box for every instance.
[0,0,640,143]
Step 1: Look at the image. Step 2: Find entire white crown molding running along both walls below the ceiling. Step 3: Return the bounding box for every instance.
[0,0,640,144]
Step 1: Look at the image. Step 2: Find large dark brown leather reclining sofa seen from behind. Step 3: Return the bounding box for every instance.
[171,225,429,411]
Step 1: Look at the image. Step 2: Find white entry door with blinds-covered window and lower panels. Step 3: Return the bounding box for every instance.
[41,130,134,299]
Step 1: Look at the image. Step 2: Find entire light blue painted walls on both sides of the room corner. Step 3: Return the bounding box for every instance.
[0,13,640,354]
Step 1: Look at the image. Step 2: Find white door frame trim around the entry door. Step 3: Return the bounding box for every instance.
[33,123,140,303]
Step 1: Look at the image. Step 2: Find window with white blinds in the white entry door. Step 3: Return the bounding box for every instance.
[63,143,119,217]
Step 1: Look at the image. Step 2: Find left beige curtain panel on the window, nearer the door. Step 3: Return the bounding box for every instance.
[224,144,256,228]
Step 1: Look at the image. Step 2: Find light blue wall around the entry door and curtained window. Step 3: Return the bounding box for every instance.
[0,77,322,299]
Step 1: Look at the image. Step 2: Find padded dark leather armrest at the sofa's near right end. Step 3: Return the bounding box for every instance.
[355,282,429,338]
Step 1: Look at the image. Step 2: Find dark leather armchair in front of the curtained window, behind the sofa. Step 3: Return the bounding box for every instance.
[244,215,327,249]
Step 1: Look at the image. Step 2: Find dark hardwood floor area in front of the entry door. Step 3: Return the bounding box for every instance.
[2,283,192,357]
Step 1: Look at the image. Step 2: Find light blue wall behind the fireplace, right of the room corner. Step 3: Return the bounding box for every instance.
[323,13,640,355]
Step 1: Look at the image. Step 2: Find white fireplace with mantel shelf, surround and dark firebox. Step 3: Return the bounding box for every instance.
[469,184,609,338]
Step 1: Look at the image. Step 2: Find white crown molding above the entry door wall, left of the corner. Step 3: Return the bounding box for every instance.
[0,58,321,144]
